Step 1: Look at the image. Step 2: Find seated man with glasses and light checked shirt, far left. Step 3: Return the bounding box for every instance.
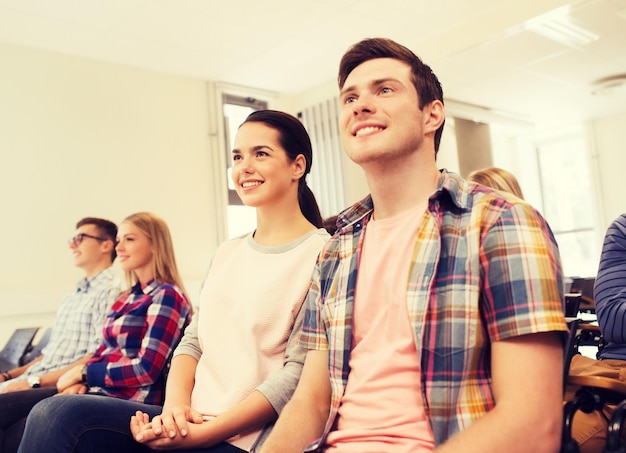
[0,217,121,452]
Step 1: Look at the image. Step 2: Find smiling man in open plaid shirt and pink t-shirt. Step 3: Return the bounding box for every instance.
[261,39,567,453]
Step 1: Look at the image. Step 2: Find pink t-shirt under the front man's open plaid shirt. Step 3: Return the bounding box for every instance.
[327,205,434,453]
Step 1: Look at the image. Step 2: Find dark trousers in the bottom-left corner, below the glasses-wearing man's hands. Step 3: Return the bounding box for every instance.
[0,387,57,453]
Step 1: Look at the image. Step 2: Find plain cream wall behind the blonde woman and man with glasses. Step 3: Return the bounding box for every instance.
[0,44,217,345]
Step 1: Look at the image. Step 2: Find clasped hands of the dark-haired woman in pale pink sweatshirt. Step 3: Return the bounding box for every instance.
[130,405,207,450]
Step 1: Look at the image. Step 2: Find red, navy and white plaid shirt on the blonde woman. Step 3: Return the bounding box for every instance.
[87,281,191,404]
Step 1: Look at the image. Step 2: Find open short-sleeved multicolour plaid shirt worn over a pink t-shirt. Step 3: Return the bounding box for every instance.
[300,170,567,450]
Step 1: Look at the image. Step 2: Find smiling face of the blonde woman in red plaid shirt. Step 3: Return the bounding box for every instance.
[115,222,154,284]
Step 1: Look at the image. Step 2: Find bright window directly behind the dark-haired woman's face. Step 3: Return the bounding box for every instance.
[222,94,267,238]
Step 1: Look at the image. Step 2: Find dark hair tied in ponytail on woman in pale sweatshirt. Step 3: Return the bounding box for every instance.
[243,110,324,228]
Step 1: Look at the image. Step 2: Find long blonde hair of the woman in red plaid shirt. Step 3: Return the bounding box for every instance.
[122,212,187,297]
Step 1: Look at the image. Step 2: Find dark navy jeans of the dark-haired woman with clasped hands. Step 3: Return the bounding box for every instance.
[19,395,243,453]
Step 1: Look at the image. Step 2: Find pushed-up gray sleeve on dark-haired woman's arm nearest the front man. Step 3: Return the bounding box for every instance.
[257,304,307,414]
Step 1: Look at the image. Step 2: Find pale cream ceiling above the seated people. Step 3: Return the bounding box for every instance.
[0,0,626,130]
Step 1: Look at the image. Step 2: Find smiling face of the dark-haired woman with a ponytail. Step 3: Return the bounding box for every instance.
[232,122,305,207]
